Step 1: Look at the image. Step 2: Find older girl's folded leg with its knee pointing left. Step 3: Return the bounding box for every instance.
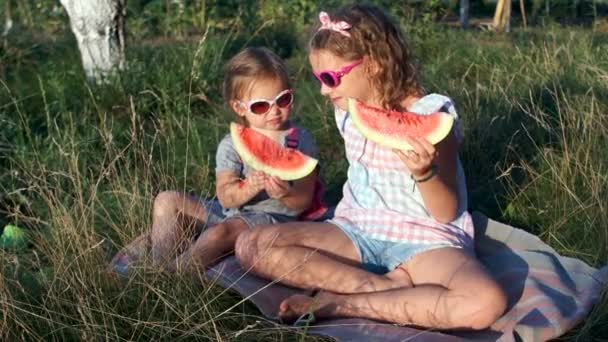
[235,222,410,293]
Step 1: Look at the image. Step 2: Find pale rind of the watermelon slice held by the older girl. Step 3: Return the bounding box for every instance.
[348,98,454,151]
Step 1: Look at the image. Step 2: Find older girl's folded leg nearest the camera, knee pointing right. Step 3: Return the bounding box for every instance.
[279,248,507,329]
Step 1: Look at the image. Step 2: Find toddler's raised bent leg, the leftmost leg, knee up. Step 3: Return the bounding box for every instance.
[150,191,207,265]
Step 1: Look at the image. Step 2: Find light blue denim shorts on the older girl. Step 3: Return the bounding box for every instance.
[327,220,454,274]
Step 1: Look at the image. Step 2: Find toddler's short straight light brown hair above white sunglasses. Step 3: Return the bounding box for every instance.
[222,47,291,124]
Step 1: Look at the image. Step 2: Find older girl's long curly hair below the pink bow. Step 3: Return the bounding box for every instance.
[308,4,423,110]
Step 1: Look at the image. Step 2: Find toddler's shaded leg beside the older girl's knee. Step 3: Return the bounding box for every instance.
[175,218,248,272]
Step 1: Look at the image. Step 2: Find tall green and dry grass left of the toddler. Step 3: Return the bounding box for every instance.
[0,26,332,340]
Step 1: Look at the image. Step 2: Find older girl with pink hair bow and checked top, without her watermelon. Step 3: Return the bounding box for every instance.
[236,5,506,329]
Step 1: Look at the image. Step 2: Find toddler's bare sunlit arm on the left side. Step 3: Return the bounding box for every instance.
[215,171,264,208]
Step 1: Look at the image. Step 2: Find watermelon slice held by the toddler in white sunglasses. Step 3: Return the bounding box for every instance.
[230,122,318,180]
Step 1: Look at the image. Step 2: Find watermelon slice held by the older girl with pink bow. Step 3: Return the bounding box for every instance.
[348,99,454,150]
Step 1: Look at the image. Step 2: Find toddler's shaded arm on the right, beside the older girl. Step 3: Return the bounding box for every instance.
[265,170,318,212]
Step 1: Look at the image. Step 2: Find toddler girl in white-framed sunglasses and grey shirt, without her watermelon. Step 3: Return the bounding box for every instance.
[111,48,317,274]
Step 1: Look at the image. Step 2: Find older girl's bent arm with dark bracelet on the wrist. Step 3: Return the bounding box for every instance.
[397,131,459,223]
